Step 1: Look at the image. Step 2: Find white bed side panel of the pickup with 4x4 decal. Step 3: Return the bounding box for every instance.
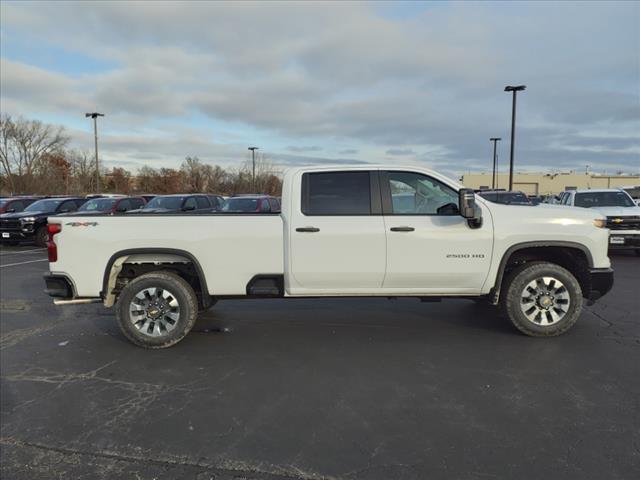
[49,213,284,297]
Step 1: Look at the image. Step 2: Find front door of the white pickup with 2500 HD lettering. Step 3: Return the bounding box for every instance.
[380,171,493,294]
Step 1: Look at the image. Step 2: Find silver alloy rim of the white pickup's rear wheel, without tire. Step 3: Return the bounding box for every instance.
[129,287,180,337]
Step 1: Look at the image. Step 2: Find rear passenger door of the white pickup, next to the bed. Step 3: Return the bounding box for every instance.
[287,170,386,294]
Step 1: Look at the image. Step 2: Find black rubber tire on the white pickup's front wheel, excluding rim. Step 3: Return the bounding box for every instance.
[501,262,584,337]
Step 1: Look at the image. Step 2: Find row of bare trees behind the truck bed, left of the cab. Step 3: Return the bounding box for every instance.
[0,114,282,195]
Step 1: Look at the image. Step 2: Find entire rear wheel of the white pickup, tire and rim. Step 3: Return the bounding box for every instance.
[116,271,198,348]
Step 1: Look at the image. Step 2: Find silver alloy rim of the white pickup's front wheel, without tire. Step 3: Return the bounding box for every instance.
[520,277,571,326]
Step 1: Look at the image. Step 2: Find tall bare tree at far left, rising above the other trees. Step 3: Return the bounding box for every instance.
[0,114,69,193]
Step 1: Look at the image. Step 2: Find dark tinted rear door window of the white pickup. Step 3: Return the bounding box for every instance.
[302,172,371,215]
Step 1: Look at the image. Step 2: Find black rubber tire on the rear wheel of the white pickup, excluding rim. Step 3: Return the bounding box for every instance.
[116,271,198,348]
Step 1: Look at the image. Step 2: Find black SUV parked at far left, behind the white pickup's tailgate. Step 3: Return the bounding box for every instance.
[0,197,86,247]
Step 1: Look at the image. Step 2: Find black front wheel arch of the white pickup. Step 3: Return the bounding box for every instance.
[489,241,593,304]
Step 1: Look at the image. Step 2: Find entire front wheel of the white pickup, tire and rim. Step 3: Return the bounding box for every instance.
[503,262,583,337]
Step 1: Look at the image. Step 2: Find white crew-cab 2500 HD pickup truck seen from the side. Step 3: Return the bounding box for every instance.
[45,165,613,348]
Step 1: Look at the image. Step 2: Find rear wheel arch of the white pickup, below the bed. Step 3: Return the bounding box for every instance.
[100,248,212,308]
